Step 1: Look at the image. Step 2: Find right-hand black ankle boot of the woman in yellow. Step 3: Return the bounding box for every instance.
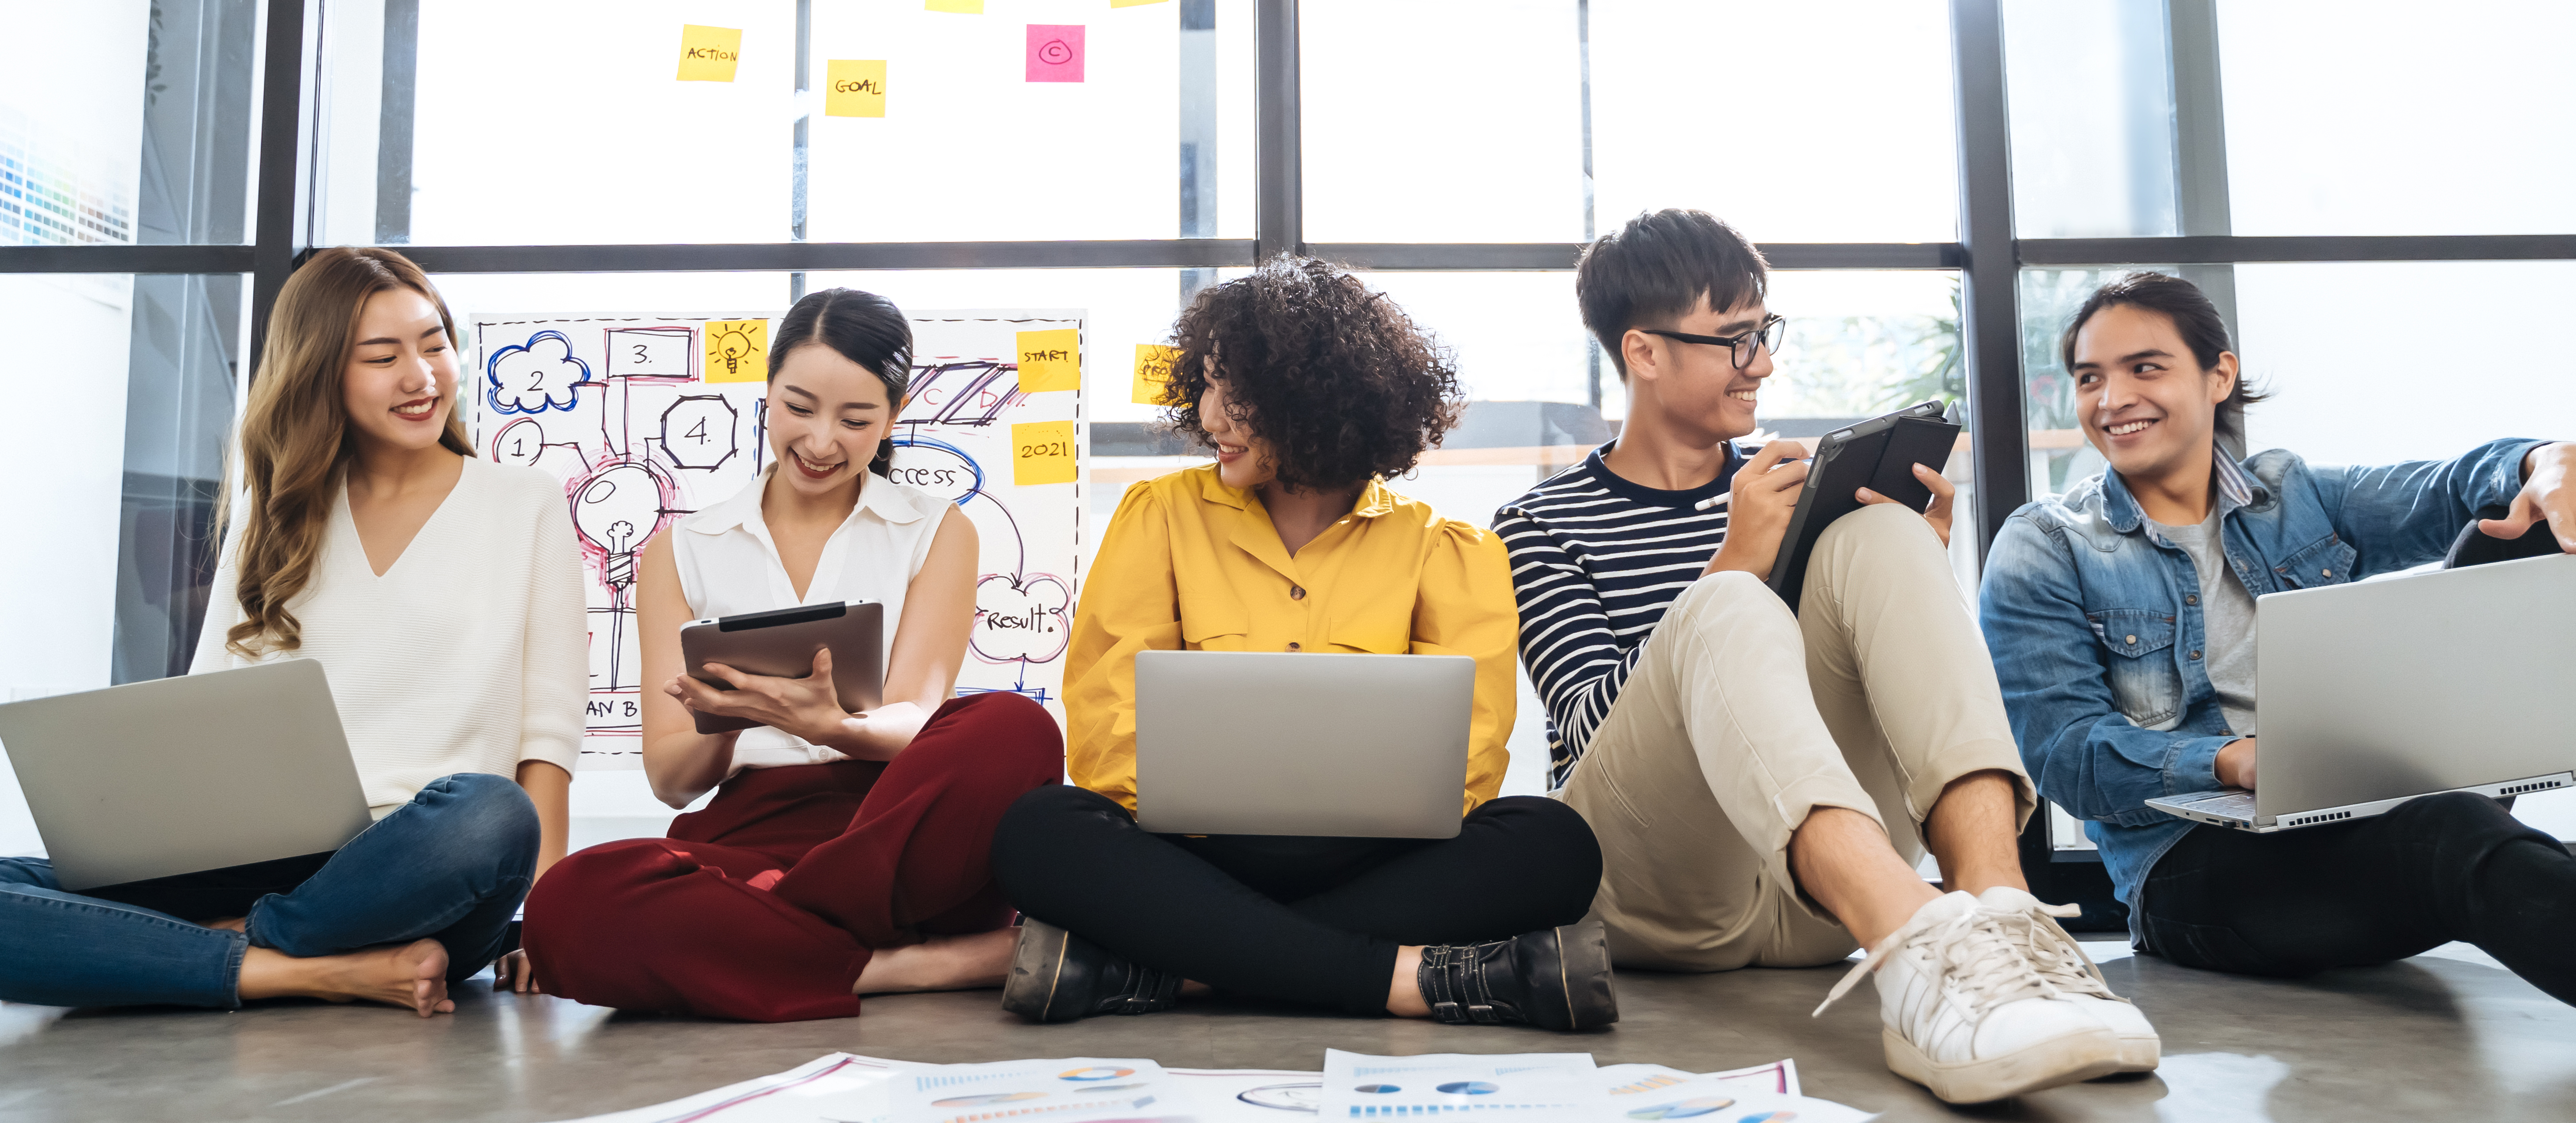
[1414,920,1618,1030]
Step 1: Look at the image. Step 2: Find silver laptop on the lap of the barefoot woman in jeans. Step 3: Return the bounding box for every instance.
[0,659,373,894]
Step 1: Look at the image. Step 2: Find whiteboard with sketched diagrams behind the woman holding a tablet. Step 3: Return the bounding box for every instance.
[461,309,1087,768]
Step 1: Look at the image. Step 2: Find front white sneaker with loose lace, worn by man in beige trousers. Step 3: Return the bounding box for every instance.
[1816,894,2120,1102]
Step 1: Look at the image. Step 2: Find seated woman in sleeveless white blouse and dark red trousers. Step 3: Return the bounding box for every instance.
[526,288,1064,1022]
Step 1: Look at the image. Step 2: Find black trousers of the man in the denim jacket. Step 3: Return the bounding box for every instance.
[2138,791,2576,1005]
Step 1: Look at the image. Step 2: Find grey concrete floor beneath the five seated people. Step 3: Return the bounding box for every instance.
[0,943,2576,1123]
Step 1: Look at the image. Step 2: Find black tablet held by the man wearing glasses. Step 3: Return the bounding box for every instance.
[1770,402,1958,613]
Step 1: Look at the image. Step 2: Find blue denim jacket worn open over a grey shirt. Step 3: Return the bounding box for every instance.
[1978,440,2540,930]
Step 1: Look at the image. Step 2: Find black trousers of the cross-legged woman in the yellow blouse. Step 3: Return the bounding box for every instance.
[992,785,1602,1015]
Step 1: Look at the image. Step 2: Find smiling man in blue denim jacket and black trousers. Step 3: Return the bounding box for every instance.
[1981,273,2576,1002]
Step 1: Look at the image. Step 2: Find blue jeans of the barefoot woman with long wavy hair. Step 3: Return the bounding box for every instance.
[0,773,538,1010]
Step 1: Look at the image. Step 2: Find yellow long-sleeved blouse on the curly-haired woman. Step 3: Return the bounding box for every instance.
[1064,466,1520,814]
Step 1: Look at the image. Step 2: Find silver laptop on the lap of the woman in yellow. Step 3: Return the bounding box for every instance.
[1136,652,1476,837]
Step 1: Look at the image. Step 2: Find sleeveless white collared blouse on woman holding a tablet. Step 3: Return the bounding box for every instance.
[670,464,948,775]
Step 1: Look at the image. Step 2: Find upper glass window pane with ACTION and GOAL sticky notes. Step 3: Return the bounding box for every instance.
[317,0,1252,245]
